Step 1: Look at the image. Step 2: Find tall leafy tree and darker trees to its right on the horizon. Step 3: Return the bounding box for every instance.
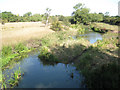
[71,3,120,25]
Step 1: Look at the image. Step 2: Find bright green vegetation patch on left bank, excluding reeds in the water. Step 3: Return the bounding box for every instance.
[0,43,30,68]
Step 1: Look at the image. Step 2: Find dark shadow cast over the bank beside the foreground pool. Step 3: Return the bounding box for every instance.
[39,44,120,88]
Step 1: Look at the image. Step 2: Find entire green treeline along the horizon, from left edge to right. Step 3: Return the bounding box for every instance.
[1,3,120,26]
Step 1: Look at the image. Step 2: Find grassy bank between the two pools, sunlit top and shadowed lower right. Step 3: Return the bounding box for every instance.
[39,28,120,88]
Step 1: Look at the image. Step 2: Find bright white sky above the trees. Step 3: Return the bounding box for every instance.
[0,0,120,16]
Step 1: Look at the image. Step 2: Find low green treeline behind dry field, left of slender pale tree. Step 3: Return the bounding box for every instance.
[1,11,45,24]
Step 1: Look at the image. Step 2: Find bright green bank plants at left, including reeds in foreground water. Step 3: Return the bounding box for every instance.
[0,43,32,89]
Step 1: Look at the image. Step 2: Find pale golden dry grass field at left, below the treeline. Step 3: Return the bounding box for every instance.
[0,22,54,45]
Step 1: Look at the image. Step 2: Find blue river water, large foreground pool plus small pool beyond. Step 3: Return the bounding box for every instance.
[3,32,102,88]
